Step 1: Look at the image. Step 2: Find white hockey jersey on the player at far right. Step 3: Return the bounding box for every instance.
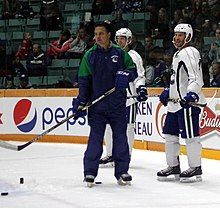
[167,46,206,112]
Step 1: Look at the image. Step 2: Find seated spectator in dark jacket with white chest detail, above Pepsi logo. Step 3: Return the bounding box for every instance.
[27,43,47,76]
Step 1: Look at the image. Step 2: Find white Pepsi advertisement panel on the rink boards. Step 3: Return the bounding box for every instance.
[0,97,89,136]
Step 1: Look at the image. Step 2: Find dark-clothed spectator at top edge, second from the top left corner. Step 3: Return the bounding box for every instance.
[18,0,36,19]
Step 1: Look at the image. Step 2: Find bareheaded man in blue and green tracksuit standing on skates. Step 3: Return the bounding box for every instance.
[73,22,141,187]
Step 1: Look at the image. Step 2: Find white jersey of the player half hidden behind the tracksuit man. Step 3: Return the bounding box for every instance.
[126,50,146,106]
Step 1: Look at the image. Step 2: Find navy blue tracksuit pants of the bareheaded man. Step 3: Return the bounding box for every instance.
[84,108,130,179]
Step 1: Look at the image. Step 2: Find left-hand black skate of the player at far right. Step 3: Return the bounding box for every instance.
[157,165,180,181]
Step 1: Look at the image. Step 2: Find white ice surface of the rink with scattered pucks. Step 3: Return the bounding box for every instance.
[0,143,220,208]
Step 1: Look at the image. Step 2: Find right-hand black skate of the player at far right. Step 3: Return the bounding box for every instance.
[180,166,202,183]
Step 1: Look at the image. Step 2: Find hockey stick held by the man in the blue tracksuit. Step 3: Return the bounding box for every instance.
[0,87,115,151]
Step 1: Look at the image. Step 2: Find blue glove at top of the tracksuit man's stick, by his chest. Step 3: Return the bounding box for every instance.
[115,69,131,90]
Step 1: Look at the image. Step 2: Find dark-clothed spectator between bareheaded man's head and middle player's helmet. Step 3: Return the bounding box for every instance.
[110,9,129,42]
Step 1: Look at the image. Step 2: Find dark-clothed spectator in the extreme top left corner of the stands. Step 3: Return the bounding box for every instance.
[2,0,20,19]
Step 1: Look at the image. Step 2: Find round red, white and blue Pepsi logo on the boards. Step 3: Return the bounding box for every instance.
[13,99,37,132]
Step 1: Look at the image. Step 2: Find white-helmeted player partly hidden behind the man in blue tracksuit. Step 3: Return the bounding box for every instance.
[100,28,148,166]
